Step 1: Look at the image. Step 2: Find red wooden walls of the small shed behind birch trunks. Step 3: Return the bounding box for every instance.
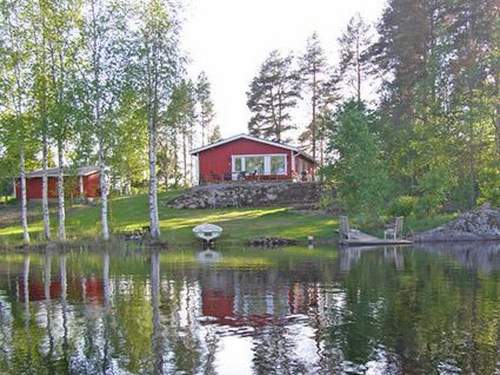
[16,173,99,200]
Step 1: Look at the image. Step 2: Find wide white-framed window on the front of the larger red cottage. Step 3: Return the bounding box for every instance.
[232,154,287,175]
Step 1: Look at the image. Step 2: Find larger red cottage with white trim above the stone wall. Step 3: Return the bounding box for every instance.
[191,134,316,184]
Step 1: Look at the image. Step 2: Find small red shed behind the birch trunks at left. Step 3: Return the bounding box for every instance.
[15,166,100,200]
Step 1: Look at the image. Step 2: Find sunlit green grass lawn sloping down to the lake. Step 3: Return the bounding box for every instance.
[0,191,452,245]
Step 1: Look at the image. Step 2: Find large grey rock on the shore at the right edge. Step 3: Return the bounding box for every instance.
[412,205,500,242]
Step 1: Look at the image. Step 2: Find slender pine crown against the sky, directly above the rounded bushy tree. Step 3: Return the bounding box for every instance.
[338,13,371,103]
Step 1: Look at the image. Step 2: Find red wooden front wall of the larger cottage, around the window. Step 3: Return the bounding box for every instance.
[198,139,292,181]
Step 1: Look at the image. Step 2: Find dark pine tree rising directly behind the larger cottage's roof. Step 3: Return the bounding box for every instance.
[247,50,300,141]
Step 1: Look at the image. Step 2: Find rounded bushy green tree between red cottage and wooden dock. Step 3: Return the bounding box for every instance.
[329,101,391,217]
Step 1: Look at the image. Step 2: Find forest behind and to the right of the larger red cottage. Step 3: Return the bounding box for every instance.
[248,0,500,222]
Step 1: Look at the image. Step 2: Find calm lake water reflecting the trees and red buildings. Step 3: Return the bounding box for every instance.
[0,245,500,375]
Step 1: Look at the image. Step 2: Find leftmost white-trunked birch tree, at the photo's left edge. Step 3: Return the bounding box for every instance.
[0,1,31,244]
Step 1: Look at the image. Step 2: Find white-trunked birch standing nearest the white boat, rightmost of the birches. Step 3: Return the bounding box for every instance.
[135,0,179,239]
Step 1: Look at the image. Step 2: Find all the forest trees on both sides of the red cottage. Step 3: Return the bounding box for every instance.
[0,0,500,247]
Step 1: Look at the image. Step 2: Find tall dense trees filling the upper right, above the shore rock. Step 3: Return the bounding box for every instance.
[365,0,500,215]
